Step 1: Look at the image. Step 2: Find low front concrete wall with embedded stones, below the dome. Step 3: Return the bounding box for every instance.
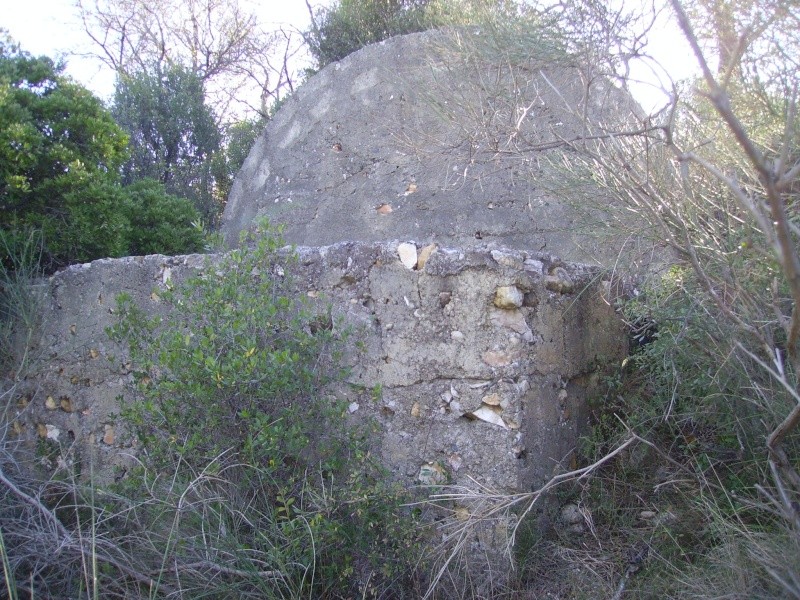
[10,242,625,500]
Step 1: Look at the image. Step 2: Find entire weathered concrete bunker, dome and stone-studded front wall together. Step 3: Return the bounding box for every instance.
[4,28,635,584]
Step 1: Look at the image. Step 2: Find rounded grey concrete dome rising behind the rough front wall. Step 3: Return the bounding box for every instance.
[222,32,648,266]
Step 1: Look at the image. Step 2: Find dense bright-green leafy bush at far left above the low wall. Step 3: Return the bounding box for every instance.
[0,35,202,271]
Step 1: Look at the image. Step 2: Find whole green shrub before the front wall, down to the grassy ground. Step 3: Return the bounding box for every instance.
[110,223,424,597]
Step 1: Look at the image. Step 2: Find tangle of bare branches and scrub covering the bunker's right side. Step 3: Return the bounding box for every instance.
[418,0,800,599]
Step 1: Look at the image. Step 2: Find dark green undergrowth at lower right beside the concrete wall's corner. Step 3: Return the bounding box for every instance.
[506,262,800,600]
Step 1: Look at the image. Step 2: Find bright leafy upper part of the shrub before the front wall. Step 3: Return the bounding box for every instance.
[108,227,343,475]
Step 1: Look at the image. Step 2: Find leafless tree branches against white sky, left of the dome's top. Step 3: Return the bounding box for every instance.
[78,0,300,116]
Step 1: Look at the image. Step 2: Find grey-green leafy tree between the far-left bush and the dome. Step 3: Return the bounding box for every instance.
[112,65,221,223]
